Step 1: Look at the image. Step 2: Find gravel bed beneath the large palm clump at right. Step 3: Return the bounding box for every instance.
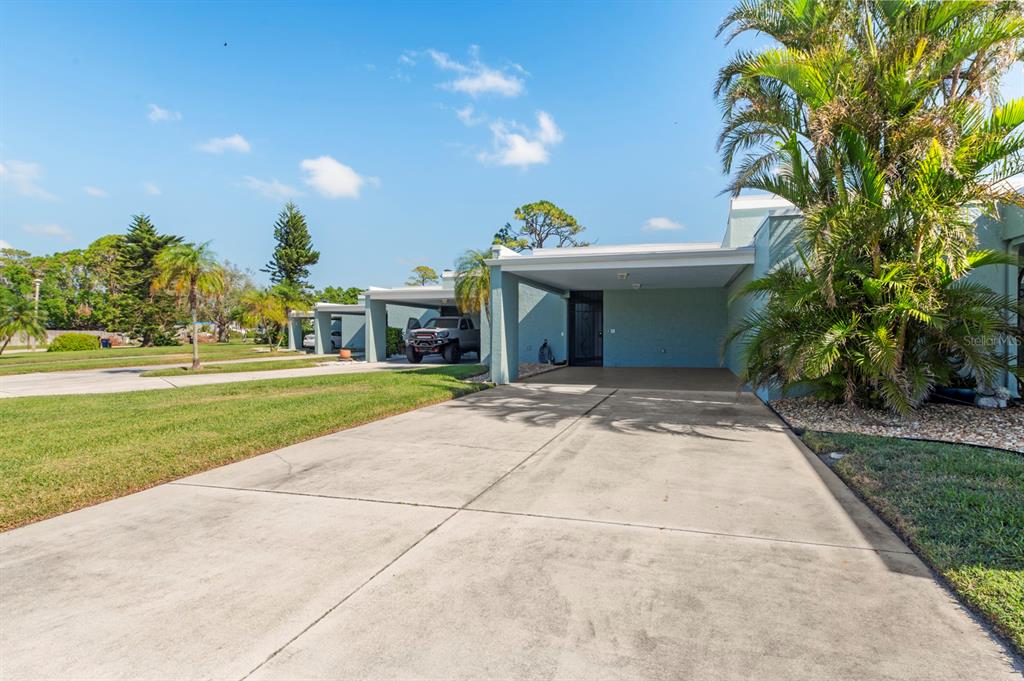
[769,397,1024,453]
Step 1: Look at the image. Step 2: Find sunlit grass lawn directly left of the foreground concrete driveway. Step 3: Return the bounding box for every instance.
[0,365,482,529]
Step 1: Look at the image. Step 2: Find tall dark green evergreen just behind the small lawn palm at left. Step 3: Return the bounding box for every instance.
[114,215,181,345]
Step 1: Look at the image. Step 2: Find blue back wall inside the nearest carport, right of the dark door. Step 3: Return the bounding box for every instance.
[604,287,728,368]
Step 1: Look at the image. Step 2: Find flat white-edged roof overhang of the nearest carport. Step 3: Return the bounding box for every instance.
[487,244,755,291]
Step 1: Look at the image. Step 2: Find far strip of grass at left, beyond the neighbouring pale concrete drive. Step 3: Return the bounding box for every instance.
[0,343,288,376]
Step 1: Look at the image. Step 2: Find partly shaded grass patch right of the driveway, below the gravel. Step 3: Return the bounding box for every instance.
[804,432,1024,652]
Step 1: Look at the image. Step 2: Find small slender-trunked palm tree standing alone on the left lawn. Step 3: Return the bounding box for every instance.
[153,242,224,371]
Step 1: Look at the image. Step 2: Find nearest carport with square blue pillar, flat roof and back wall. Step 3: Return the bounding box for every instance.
[487,244,756,384]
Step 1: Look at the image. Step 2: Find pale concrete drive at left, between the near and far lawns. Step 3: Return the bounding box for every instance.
[0,354,436,397]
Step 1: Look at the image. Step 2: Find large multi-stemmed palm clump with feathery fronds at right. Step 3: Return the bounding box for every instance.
[716,0,1024,412]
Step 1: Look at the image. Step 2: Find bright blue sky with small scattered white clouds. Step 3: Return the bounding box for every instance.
[6,2,782,287]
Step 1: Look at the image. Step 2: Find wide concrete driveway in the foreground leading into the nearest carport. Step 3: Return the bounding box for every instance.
[0,371,1022,681]
